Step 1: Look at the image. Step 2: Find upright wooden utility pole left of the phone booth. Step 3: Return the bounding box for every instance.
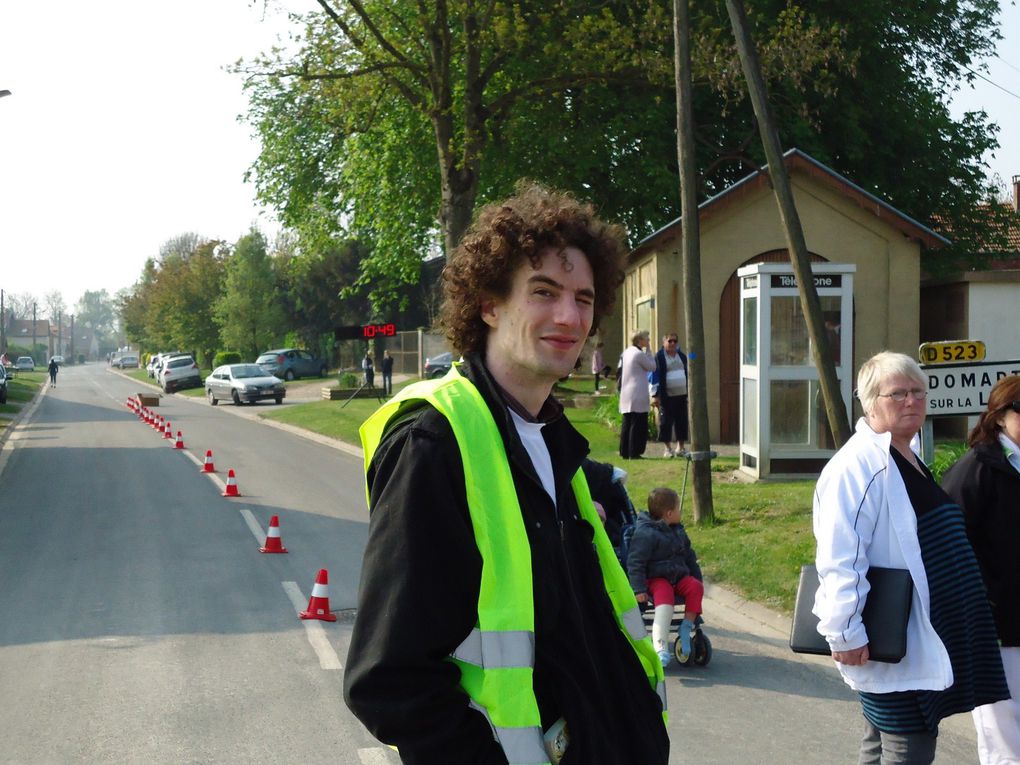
[673,0,715,524]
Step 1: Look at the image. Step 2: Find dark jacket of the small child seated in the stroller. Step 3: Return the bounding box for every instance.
[627,513,702,593]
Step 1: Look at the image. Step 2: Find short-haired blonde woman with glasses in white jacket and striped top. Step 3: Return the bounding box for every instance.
[814,351,1009,765]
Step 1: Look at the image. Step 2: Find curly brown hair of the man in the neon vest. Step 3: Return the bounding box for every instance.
[440,182,626,354]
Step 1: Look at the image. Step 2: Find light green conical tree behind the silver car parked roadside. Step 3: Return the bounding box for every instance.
[213,228,286,360]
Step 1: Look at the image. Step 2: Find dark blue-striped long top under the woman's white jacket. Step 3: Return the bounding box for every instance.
[860,449,1010,733]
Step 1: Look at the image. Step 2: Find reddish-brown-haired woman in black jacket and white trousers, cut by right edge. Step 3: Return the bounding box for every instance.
[942,374,1020,765]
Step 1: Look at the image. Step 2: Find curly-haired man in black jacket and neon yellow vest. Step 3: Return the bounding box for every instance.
[345,186,669,765]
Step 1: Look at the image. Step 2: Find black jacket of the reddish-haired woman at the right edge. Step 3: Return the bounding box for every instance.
[942,442,1020,647]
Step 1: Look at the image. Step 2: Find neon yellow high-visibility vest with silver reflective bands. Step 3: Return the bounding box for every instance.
[360,365,666,765]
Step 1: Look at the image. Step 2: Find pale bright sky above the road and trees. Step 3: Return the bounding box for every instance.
[0,0,1020,318]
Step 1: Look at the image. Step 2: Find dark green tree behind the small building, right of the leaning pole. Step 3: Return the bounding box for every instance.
[714,0,1006,272]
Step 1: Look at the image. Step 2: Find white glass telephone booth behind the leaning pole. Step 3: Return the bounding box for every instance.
[736,263,857,478]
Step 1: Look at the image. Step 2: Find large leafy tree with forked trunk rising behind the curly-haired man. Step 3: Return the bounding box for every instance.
[239,0,837,305]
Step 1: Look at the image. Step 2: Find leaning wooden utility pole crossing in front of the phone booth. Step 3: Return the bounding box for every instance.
[726,0,851,449]
